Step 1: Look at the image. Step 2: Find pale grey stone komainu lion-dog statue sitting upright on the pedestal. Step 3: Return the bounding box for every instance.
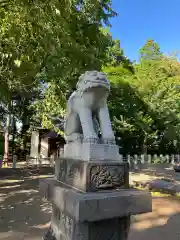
[65,71,115,144]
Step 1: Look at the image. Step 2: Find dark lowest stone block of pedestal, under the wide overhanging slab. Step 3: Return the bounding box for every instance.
[49,207,130,240]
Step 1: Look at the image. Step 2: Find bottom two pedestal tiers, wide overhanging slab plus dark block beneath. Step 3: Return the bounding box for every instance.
[41,179,152,240]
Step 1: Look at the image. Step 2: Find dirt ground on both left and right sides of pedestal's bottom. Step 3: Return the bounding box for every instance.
[0,175,180,240]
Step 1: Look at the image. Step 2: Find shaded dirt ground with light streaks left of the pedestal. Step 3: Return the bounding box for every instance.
[0,169,51,240]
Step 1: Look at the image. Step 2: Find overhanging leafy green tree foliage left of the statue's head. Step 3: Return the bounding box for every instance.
[0,0,116,131]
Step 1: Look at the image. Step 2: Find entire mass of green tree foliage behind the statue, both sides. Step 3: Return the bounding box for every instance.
[0,0,180,156]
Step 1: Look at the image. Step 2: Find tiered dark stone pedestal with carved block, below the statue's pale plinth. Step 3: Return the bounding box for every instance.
[40,143,152,240]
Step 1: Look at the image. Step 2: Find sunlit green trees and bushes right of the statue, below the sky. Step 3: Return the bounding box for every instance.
[104,38,180,153]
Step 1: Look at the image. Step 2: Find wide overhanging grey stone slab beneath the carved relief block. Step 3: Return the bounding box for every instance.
[53,186,152,222]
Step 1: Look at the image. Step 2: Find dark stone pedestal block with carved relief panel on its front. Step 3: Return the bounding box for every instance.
[55,159,129,192]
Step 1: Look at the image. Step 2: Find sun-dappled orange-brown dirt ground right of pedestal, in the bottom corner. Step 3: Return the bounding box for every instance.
[129,197,180,240]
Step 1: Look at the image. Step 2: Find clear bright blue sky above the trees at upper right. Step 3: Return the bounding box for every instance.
[111,0,180,60]
